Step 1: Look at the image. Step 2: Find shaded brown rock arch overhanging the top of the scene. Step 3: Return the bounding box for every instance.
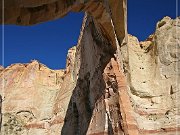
[0,0,127,50]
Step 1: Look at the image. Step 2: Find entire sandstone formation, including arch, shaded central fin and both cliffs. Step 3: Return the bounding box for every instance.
[0,0,180,135]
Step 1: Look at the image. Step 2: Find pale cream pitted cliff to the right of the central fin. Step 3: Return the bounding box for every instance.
[122,17,180,135]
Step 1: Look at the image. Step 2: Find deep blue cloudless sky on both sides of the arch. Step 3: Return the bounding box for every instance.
[0,0,176,69]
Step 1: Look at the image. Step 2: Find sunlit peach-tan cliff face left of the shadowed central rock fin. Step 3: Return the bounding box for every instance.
[0,61,64,134]
